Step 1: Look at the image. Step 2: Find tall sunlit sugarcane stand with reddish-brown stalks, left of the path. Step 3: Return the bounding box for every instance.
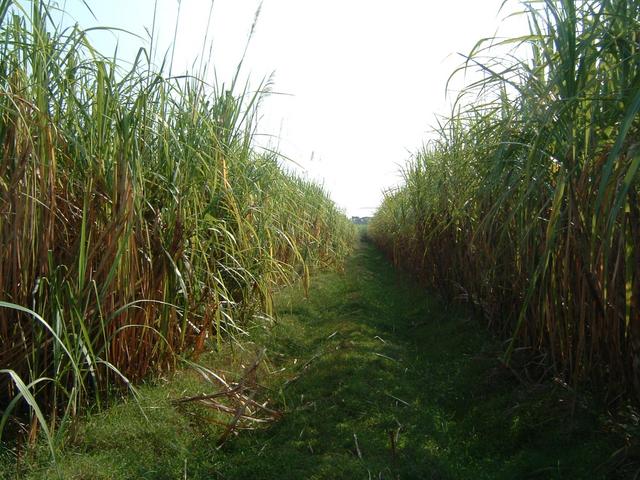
[0,0,355,456]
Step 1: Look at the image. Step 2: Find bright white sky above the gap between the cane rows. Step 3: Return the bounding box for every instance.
[60,0,525,216]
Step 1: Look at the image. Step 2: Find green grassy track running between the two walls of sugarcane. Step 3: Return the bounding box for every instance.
[16,240,616,479]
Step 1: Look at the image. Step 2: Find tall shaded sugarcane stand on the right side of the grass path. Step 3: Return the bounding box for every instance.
[369,0,640,401]
